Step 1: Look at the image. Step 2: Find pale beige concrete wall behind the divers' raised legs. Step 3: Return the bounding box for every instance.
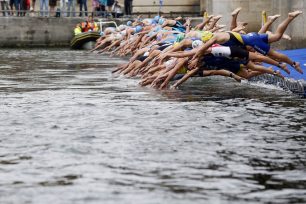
[200,0,306,49]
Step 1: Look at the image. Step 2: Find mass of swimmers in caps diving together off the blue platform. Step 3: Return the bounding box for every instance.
[91,8,303,89]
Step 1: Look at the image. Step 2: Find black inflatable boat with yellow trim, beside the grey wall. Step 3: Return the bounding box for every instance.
[70,31,100,50]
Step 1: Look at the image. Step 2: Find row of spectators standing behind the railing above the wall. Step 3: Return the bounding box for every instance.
[0,0,132,18]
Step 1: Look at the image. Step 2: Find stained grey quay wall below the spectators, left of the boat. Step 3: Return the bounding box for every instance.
[0,17,124,47]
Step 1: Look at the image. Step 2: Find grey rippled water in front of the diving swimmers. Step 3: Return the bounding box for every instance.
[0,50,306,204]
